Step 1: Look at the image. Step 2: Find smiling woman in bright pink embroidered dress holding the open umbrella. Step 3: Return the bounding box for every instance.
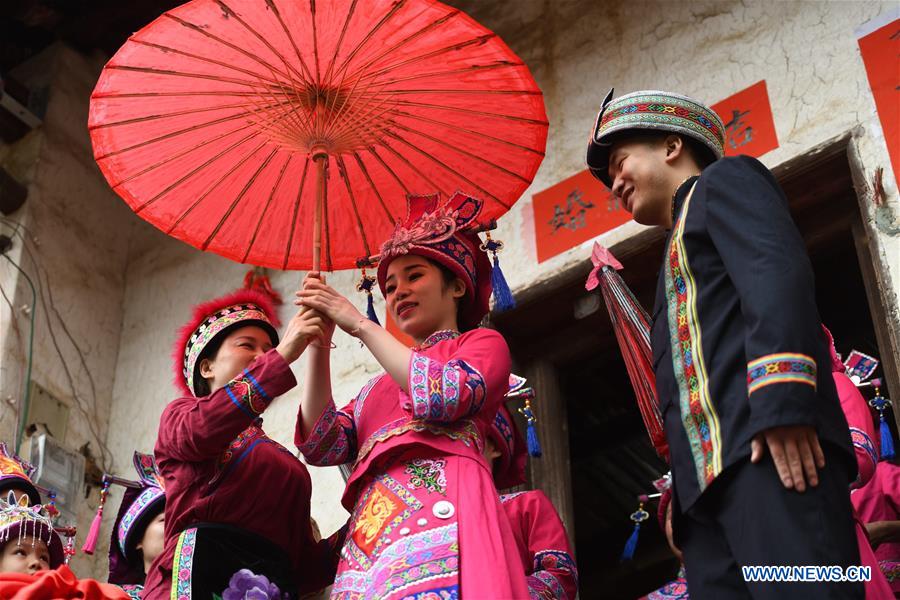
[296,193,528,600]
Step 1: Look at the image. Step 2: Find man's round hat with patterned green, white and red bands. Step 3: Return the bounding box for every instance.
[586,89,725,187]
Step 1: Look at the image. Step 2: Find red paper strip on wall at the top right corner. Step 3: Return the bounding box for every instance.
[859,19,900,183]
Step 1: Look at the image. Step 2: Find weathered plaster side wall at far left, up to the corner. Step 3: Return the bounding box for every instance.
[0,45,134,572]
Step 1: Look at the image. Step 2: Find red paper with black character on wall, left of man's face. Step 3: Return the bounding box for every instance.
[533,170,631,262]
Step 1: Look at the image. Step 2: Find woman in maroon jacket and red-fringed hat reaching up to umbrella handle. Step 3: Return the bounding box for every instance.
[143,290,337,600]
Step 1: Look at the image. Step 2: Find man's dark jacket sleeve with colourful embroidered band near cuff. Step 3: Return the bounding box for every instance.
[696,156,830,434]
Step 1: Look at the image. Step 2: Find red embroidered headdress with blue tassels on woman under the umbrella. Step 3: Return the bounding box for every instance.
[360,192,513,329]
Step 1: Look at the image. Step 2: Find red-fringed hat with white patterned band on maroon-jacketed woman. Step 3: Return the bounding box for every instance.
[172,290,278,396]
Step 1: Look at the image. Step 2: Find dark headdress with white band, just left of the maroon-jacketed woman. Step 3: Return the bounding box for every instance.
[107,452,166,585]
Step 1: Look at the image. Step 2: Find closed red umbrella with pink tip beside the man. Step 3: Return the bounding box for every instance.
[584,242,669,462]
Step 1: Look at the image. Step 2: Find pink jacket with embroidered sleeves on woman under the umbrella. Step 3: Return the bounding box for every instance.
[295,328,510,511]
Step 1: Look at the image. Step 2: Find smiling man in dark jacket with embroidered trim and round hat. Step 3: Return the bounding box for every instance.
[587,91,863,600]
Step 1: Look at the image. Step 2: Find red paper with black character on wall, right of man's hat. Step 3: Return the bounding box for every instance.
[712,79,778,158]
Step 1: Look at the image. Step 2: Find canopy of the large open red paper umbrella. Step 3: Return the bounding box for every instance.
[89,0,547,270]
